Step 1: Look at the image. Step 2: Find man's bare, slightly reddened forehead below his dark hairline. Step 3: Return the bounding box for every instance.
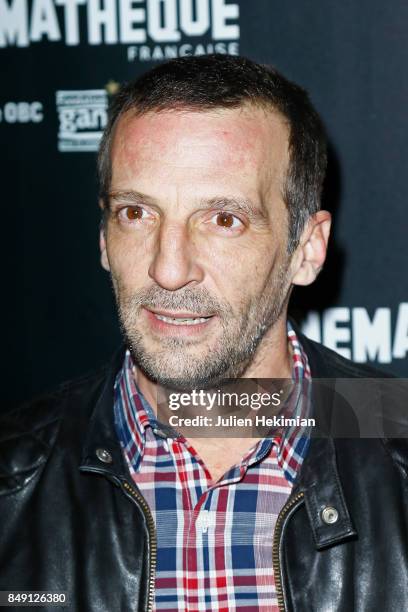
[111,106,289,198]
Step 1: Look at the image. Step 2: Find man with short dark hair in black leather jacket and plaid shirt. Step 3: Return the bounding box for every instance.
[0,55,408,612]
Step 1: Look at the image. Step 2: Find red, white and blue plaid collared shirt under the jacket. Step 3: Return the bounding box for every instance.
[114,323,311,612]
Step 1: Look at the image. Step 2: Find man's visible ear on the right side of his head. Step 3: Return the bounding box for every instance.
[292,210,331,285]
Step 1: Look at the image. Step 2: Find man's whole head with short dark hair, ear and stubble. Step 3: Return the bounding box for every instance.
[99,56,329,388]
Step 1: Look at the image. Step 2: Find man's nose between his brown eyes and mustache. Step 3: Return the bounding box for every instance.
[149,223,204,291]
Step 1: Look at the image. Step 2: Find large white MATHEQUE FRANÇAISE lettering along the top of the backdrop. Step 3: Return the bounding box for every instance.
[0,0,240,61]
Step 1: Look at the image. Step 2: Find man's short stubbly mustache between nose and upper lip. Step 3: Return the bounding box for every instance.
[119,286,231,316]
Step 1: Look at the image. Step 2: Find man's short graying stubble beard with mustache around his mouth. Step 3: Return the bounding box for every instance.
[114,264,289,391]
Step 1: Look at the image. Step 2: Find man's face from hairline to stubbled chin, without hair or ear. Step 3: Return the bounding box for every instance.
[101,107,291,389]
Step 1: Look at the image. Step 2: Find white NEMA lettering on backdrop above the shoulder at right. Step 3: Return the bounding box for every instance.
[302,302,408,363]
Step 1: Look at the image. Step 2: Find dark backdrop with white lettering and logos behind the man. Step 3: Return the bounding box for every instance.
[0,0,408,405]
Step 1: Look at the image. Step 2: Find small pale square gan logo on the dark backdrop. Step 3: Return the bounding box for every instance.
[56,89,108,153]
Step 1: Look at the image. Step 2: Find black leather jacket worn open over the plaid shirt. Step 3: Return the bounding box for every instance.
[0,335,408,612]
